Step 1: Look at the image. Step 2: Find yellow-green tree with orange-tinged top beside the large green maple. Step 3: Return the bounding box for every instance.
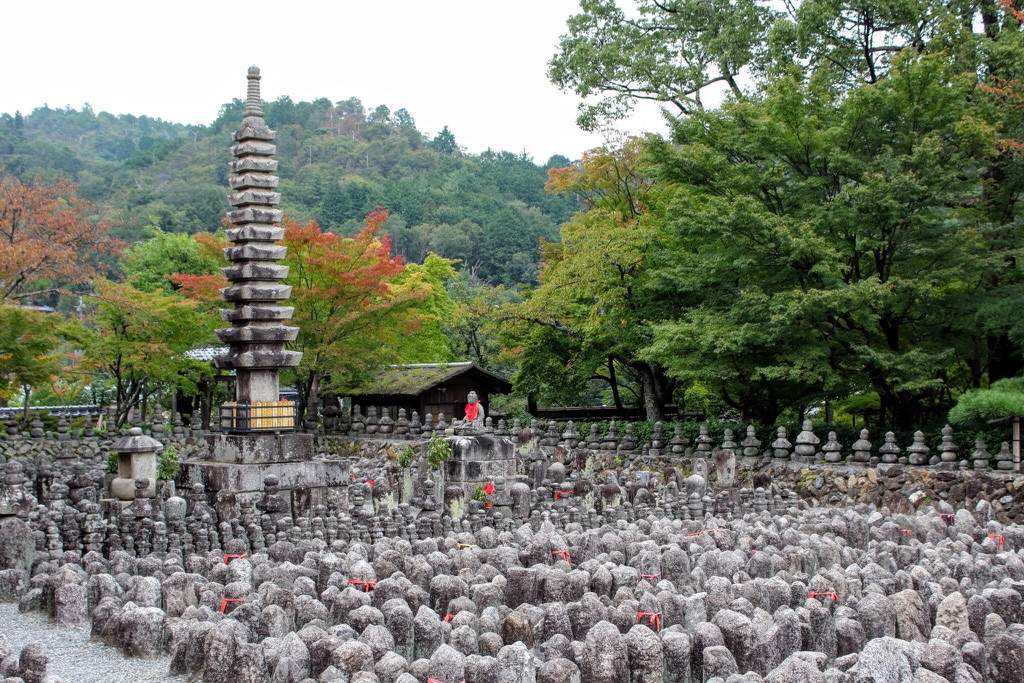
[504,139,676,420]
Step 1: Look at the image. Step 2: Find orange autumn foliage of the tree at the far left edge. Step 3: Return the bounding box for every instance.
[0,176,111,301]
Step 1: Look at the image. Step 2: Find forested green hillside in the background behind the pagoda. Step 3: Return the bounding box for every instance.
[0,97,575,286]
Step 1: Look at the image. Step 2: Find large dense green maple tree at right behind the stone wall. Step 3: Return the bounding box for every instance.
[651,55,1008,427]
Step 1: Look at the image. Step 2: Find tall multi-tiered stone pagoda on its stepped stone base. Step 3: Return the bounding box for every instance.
[181,67,348,498]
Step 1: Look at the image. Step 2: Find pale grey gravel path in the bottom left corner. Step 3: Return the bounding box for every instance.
[0,603,185,683]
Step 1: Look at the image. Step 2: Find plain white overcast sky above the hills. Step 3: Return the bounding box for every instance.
[0,0,664,163]
